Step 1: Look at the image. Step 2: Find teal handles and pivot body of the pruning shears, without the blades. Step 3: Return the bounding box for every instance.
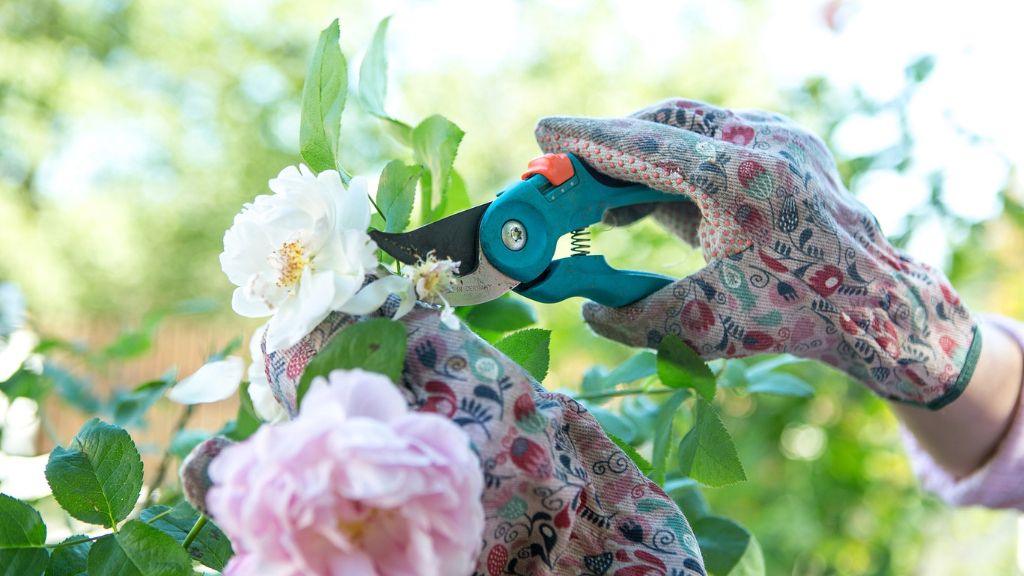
[480,154,687,306]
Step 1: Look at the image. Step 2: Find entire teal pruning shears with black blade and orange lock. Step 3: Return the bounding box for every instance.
[370,154,687,307]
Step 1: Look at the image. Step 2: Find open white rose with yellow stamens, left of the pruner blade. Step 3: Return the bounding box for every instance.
[220,165,394,353]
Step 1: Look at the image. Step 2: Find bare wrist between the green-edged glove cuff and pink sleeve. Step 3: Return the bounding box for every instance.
[893,322,1024,478]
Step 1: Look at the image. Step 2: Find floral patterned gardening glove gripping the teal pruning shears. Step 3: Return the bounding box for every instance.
[537,99,981,410]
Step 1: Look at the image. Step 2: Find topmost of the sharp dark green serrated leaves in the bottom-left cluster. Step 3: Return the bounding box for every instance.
[46,418,142,528]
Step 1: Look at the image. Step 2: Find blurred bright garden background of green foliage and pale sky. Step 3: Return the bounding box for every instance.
[0,0,1024,575]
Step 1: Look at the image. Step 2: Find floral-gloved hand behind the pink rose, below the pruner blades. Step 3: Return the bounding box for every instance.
[260,298,705,576]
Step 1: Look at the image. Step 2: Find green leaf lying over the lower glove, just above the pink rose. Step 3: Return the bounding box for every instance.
[294,318,408,406]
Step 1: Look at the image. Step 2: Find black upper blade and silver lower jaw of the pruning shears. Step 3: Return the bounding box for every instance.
[370,203,519,306]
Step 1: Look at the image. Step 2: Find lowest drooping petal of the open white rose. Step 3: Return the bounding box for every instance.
[266,268,335,353]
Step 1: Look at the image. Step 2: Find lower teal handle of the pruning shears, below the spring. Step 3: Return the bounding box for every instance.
[516,255,673,307]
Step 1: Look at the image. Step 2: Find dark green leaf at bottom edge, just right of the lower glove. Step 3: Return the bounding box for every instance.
[690,516,765,576]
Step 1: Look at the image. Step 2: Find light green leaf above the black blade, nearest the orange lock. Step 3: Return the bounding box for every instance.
[413,114,465,221]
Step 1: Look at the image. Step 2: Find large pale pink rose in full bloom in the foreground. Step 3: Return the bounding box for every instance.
[206,370,483,576]
